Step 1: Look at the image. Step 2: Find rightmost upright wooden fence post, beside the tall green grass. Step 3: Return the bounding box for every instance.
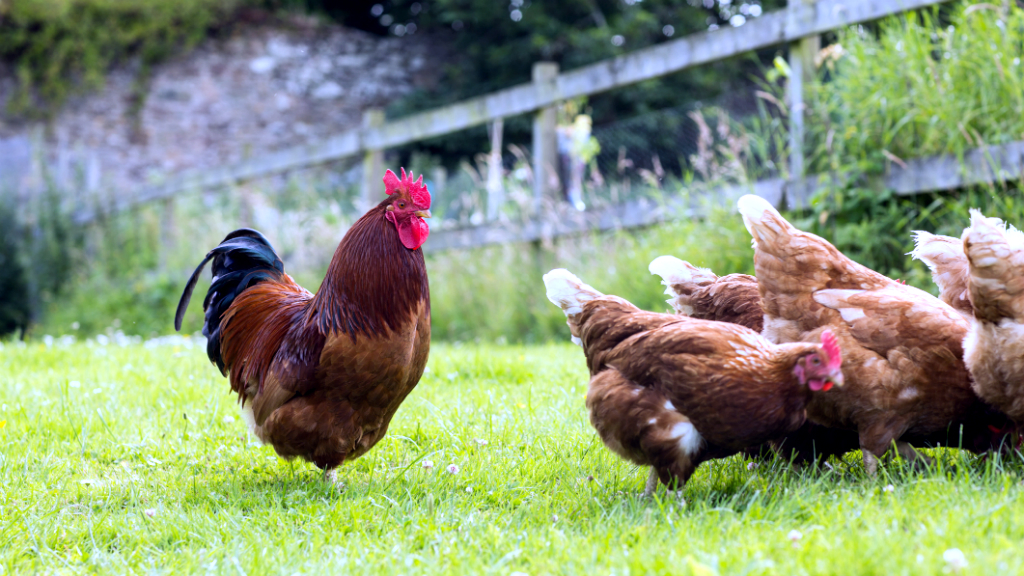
[786,0,821,208]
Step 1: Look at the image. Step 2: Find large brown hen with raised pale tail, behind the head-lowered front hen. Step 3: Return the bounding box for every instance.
[738,196,983,475]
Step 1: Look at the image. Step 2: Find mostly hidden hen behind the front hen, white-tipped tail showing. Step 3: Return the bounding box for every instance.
[648,256,859,464]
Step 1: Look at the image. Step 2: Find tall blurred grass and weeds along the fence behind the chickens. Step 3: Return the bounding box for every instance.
[22,4,1024,341]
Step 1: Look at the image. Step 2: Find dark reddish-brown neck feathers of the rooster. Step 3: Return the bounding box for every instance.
[307,200,430,338]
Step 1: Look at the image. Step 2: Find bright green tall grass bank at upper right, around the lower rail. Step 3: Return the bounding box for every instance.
[782,3,1024,278]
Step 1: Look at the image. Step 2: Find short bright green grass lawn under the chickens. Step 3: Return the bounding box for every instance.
[0,341,1024,575]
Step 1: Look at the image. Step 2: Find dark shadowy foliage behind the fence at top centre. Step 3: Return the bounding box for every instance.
[384,0,784,166]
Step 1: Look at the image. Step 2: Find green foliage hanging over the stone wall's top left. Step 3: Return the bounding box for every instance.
[0,0,239,117]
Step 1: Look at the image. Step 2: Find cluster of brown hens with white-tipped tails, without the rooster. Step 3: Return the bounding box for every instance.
[544,196,1024,493]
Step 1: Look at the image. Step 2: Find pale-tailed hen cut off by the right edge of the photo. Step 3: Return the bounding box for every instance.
[963,210,1024,424]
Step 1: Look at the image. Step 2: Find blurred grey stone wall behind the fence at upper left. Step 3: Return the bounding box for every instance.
[0,18,445,199]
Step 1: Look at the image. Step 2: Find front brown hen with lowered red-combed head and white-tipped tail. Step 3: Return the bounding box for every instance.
[544,270,843,495]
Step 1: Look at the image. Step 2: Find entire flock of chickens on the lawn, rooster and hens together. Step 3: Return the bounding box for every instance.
[175,166,1024,493]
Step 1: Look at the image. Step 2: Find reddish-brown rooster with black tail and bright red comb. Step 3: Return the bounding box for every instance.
[174,169,430,478]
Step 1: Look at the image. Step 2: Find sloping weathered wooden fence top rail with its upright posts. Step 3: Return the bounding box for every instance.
[74,0,948,249]
